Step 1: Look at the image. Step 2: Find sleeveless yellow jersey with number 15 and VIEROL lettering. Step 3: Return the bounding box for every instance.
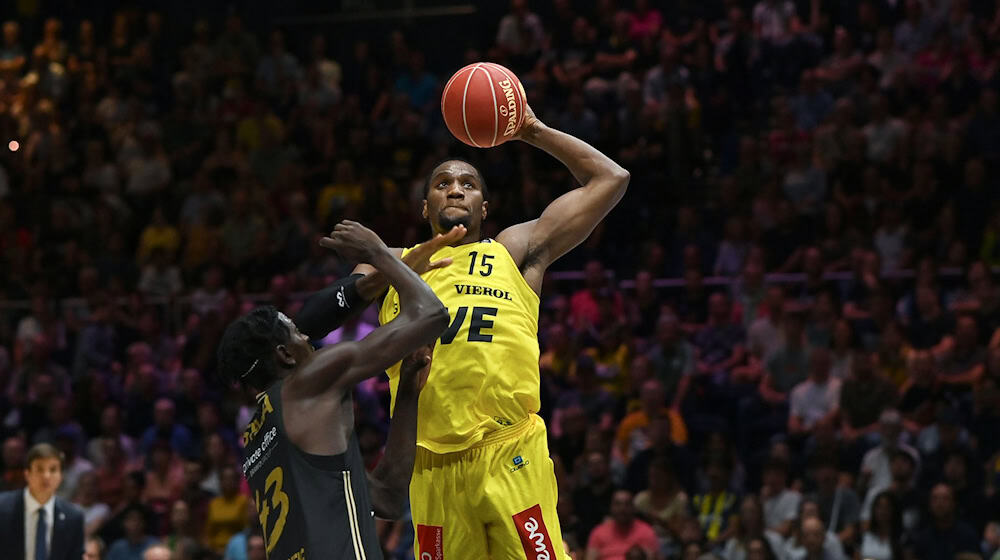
[379,239,539,453]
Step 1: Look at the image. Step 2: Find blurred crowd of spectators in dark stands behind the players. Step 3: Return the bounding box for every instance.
[0,0,1000,560]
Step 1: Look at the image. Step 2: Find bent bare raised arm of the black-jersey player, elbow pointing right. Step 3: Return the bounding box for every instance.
[296,221,448,395]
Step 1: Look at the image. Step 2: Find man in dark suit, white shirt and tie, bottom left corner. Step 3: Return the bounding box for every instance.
[0,443,83,560]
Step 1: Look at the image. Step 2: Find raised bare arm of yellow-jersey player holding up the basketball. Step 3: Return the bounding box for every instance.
[497,107,629,291]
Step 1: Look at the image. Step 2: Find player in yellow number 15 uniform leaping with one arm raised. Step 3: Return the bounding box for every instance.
[355,103,629,560]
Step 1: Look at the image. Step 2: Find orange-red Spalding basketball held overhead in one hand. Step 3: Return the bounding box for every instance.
[441,62,526,148]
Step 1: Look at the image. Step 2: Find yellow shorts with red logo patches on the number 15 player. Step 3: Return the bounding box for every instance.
[410,414,568,560]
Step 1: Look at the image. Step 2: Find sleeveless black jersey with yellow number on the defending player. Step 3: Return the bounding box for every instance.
[243,381,382,560]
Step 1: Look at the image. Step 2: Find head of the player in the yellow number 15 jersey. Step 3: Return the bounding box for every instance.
[423,161,488,235]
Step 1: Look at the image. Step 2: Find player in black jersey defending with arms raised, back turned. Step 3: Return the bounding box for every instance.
[219,222,465,560]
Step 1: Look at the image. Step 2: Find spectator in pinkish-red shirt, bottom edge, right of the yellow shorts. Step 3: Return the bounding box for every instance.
[587,490,659,560]
